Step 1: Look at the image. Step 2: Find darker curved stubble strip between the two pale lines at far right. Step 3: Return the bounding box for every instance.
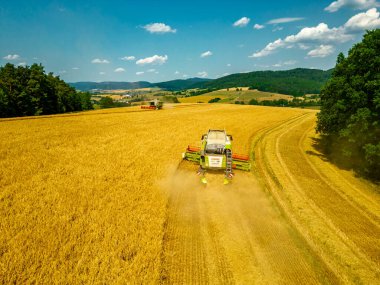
[276,115,380,268]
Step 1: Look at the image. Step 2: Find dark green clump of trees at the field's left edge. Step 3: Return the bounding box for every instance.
[0,63,93,118]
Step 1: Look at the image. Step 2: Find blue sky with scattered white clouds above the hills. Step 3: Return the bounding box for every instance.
[0,0,380,82]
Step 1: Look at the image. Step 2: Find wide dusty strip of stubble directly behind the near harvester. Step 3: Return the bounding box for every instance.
[161,112,339,284]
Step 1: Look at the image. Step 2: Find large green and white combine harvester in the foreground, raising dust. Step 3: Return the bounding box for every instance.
[182,130,251,185]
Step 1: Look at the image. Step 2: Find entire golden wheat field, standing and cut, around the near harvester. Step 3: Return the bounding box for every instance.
[0,104,380,284]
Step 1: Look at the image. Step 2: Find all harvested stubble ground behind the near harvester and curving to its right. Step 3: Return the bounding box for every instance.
[161,110,380,284]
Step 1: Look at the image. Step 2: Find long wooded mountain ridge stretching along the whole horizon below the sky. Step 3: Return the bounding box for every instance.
[69,68,333,96]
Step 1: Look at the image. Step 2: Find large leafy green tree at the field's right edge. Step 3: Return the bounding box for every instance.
[317,29,380,179]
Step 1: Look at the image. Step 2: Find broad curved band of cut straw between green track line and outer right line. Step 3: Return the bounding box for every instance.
[256,112,379,283]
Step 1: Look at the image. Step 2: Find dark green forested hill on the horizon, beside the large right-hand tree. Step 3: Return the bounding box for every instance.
[197,68,332,96]
